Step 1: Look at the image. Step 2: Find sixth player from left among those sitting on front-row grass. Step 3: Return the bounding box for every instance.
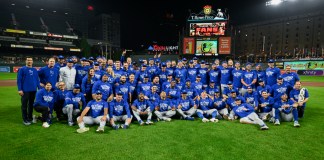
[196,91,218,122]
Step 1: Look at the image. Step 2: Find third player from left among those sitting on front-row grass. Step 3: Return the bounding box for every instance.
[132,92,153,126]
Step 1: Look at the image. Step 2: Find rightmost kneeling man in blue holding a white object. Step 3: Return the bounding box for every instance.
[289,81,309,118]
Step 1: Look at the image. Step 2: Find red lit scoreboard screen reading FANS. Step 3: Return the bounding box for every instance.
[189,22,226,37]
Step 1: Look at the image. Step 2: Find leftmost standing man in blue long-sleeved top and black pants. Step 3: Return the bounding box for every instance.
[17,57,41,125]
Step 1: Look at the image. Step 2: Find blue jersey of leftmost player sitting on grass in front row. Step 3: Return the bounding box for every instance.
[86,100,108,118]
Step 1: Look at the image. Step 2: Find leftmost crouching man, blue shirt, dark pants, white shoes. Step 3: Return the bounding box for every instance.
[34,82,54,128]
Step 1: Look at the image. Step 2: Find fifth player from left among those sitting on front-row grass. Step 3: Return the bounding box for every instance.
[177,90,197,121]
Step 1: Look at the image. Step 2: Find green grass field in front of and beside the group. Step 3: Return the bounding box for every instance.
[0,84,324,160]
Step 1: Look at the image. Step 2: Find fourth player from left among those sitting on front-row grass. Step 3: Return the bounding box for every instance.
[154,91,176,121]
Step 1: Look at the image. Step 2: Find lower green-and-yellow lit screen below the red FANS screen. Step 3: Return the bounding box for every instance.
[196,39,218,56]
